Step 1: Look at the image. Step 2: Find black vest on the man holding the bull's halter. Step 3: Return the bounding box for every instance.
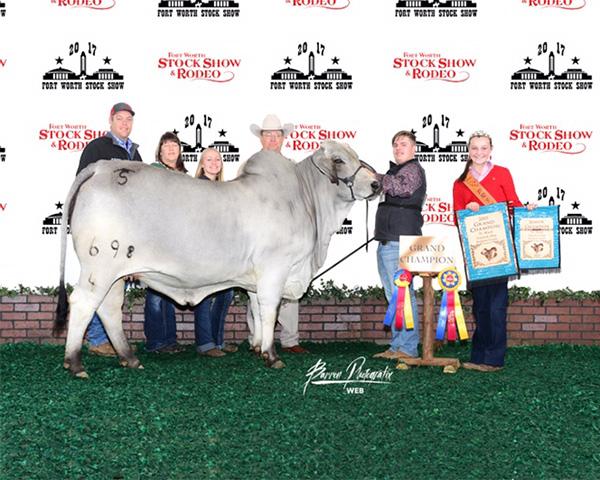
[375,159,427,242]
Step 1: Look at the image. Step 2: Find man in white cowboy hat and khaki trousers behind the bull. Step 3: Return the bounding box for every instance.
[246,114,308,353]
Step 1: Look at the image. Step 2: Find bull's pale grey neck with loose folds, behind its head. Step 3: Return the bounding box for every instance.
[296,157,354,274]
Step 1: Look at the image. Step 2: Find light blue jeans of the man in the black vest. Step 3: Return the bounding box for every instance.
[377,242,419,357]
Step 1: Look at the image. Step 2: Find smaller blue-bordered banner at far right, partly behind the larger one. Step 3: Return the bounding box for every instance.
[513,205,560,271]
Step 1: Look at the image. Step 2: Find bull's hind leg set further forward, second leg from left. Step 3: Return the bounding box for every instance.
[98,280,143,368]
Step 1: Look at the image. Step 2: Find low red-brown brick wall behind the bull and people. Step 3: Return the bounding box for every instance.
[0,295,600,345]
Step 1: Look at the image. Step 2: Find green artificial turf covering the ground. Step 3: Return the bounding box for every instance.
[0,343,600,480]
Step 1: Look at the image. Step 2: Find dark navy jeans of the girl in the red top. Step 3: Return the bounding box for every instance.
[471,280,508,367]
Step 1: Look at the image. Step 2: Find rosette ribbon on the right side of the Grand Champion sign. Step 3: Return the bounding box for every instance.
[435,267,469,341]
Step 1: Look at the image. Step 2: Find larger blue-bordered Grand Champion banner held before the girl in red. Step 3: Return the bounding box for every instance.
[456,203,519,282]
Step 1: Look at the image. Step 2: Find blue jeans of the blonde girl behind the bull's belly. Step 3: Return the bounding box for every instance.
[194,288,233,352]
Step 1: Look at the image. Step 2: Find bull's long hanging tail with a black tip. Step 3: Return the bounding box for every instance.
[53,164,96,336]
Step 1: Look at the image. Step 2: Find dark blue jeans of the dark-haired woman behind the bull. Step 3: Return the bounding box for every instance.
[144,288,177,352]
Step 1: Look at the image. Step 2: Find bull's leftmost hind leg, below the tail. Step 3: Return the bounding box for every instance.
[63,285,99,378]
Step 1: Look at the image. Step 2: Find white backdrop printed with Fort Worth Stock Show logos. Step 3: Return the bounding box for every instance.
[0,0,600,290]
